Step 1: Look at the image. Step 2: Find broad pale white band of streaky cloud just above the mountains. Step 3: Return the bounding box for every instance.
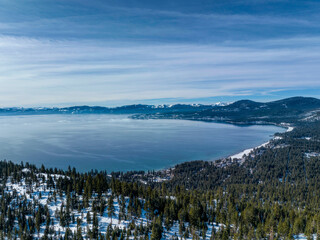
[0,36,320,106]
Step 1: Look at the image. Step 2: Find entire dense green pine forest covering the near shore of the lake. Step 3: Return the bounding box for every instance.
[0,120,320,239]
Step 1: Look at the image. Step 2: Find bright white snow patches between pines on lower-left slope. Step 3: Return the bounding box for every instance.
[1,172,221,240]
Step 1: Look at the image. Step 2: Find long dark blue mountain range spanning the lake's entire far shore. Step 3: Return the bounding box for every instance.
[0,97,320,124]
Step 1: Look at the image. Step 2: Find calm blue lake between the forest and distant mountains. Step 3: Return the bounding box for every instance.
[0,114,285,172]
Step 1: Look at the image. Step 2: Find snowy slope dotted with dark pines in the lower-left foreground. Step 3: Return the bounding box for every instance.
[0,162,222,239]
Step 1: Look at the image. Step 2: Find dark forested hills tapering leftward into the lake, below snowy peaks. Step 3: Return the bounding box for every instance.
[134,97,320,124]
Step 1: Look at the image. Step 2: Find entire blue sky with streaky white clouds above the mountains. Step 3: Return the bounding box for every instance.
[0,0,320,107]
